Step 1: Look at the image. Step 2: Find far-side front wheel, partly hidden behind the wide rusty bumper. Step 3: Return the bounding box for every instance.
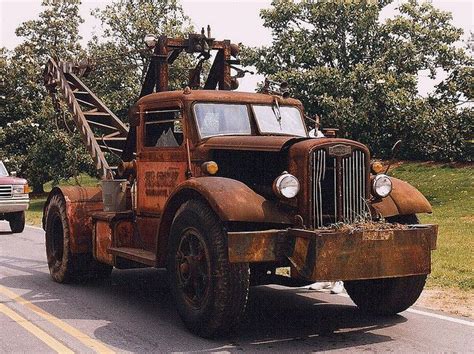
[344,214,426,315]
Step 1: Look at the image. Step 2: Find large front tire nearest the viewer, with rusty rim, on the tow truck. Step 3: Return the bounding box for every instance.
[168,200,250,337]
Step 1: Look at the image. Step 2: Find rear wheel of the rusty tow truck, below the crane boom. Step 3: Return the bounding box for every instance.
[46,195,106,283]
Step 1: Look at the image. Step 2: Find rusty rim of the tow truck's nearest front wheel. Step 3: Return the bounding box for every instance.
[175,229,210,308]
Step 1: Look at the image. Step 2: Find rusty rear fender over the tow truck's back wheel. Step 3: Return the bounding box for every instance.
[43,187,103,253]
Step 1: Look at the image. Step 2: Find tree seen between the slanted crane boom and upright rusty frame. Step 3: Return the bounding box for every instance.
[87,0,193,118]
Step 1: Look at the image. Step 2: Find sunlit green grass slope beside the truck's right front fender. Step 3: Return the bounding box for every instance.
[391,163,474,290]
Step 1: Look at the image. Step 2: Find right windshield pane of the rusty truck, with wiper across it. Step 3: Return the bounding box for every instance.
[252,104,307,136]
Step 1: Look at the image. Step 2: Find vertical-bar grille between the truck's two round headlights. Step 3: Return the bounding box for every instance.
[310,149,367,228]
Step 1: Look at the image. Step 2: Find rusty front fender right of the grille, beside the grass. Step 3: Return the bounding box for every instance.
[372,177,432,217]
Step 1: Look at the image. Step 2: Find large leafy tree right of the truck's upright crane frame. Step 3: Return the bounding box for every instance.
[242,0,472,160]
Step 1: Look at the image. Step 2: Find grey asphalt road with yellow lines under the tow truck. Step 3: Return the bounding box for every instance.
[0,222,474,353]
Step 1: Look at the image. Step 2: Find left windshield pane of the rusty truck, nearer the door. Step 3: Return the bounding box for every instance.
[194,103,252,138]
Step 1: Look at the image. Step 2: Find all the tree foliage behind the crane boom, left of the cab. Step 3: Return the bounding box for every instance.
[0,0,202,192]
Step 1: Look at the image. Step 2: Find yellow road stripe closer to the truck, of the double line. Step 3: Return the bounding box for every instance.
[0,285,115,353]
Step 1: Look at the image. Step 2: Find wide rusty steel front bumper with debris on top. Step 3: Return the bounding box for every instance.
[228,224,438,281]
